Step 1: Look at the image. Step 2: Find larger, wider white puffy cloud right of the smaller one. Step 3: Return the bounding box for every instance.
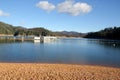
[57,0,92,16]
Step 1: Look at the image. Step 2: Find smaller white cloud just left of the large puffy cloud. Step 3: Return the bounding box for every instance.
[36,1,55,12]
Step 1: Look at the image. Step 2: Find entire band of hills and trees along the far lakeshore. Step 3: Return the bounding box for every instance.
[0,22,120,40]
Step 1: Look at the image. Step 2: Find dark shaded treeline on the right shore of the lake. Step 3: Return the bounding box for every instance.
[85,27,120,40]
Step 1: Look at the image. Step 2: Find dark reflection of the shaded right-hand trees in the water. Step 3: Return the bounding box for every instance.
[97,40,120,48]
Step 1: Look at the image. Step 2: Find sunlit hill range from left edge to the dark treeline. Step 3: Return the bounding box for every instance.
[0,22,84,37]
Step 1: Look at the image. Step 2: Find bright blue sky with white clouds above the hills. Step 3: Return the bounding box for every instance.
[0,0,120,33]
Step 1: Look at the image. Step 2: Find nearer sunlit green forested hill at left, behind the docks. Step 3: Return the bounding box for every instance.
[0,22,53,36]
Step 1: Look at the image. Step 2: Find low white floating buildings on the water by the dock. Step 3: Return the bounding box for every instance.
[34,36,57,42]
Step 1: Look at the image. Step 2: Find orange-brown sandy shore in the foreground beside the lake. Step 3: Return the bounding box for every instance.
[0,63,120,80]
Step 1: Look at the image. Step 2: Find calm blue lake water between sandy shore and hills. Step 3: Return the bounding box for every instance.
[0,38,120,67]
